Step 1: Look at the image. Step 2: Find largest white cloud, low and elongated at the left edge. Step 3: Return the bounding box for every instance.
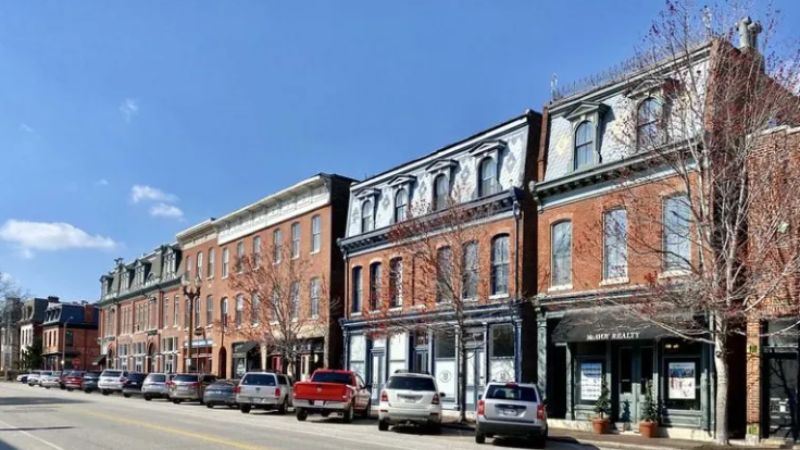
[0,219,117,258]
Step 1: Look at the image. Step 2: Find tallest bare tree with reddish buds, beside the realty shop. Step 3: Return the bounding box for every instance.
[576,1,800,443]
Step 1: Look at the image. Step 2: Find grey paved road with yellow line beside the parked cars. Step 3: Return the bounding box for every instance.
[0,383,600,450]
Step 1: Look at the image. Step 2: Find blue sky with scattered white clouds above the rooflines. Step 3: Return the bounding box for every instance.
[0,0,800,300]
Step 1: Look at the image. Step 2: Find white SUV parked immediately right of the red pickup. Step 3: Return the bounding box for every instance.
[378,373,444,433]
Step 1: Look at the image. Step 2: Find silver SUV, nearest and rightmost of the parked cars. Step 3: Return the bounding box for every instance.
[475,382,547,447]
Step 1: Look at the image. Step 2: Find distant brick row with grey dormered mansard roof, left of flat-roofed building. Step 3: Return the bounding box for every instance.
[97,244,188,372]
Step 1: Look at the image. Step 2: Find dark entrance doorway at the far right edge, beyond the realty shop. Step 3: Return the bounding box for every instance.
[764,352,800,441]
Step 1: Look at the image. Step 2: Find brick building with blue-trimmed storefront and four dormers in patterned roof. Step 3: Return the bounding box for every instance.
[340,111,540,411]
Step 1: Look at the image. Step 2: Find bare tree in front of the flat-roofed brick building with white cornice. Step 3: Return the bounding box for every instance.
[225,244,340,376]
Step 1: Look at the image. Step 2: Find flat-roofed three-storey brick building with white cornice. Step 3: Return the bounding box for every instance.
[177,174,352,379]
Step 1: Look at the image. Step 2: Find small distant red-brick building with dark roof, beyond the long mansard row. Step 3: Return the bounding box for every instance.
[42,302,100,370]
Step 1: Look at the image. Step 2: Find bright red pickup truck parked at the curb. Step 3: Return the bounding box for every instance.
[292,369,371,423]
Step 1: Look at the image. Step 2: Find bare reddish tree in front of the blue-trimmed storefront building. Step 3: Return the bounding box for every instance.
[364,189,514,422]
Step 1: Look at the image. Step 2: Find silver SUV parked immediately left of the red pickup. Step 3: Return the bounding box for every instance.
[235,372,292,414]
